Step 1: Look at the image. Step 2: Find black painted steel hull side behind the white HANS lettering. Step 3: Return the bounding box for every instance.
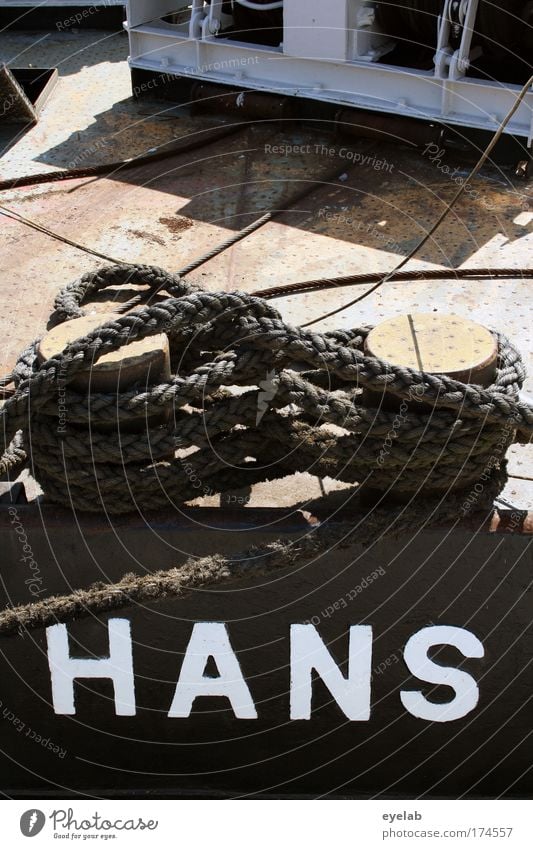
[0,507,533,798]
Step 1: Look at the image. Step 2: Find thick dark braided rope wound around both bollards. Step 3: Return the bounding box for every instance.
[0,265,533,514]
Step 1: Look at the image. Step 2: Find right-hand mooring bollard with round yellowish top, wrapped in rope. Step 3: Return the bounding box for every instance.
[361,313,498,506]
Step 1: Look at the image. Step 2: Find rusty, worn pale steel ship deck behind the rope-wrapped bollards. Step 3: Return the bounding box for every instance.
[0,27,533,510]
